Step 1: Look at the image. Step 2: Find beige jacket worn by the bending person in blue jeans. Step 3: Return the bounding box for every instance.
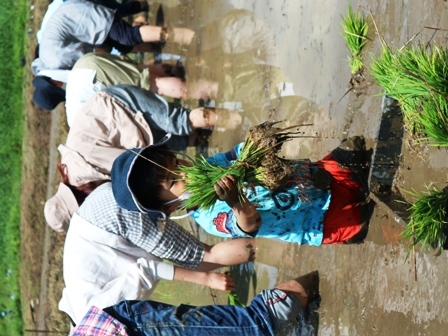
[58,92,154,186]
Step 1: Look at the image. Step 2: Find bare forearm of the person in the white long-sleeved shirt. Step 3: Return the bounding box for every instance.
[174,266,235,291]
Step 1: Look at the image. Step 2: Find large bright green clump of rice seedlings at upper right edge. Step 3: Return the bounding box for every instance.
[370,43,448,146]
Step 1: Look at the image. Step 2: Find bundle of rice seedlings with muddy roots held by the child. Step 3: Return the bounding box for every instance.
[179,122,307,210]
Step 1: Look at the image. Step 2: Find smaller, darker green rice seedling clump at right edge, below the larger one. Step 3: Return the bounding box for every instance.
[401,187,448,250]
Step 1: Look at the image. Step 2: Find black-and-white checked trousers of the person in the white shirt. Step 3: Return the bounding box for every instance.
[78,182,205,269]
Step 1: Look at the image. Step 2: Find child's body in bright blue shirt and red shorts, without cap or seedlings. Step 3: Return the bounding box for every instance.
[150,137,371,246]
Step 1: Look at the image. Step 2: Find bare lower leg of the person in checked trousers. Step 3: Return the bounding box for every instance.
[196,238,256,271]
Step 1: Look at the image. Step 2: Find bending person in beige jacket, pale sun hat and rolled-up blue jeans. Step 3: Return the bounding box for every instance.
[44,85,242,232]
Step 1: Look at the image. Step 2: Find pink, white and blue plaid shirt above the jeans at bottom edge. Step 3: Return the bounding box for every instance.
[71,307,129,336]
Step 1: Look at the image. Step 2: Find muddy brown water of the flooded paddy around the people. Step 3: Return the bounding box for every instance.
[156,0,448,335]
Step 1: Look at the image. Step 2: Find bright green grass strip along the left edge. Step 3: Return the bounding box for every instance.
[0,0,28,335]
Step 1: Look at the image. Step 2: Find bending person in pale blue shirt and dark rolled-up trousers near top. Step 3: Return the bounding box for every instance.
[39,0,194,69]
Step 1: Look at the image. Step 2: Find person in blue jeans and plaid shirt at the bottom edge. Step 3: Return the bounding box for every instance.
[71,271,320,336]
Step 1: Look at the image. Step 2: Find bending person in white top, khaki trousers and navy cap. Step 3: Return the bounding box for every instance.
[32,52,212,115]
